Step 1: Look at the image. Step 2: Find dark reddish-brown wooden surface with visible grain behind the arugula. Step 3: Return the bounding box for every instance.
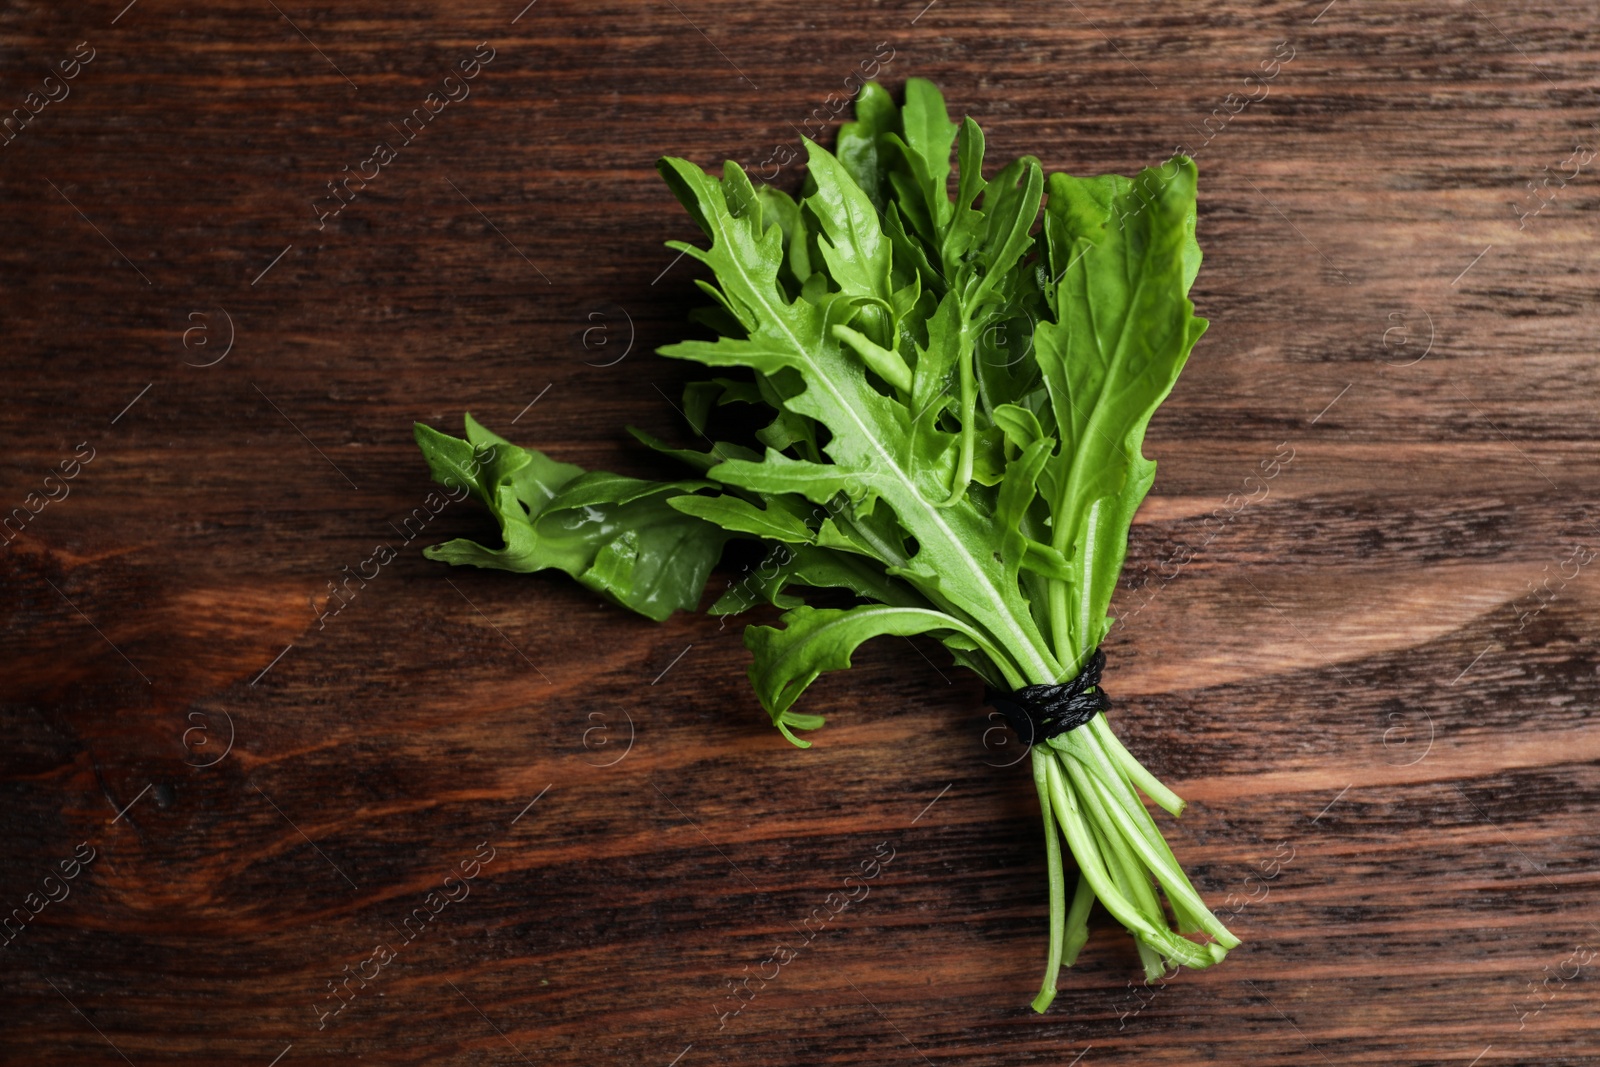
[0,0,1600,1067]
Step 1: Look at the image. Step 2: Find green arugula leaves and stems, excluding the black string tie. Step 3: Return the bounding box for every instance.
[416,78,1238,1011]
